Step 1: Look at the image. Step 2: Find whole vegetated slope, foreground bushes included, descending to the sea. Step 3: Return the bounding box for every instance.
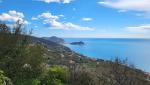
[0,22,150,85]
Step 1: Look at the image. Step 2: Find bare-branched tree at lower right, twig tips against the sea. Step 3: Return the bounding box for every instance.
[109,58,135,85]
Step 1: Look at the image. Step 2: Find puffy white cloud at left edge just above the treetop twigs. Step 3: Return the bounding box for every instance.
[0,10,29,24]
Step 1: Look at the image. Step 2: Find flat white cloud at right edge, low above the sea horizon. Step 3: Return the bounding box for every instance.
[126,24,150,33]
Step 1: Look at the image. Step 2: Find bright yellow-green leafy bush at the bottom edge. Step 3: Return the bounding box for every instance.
[41,65,69,85]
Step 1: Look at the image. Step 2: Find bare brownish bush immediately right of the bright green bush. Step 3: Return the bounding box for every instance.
[69,64,96,85]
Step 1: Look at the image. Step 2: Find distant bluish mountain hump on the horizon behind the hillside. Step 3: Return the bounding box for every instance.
[43,36,65,44]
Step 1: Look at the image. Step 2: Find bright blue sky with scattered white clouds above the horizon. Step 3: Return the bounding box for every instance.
[0,0,150,38]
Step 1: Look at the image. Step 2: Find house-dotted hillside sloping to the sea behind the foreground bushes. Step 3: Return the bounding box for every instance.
[32,37,150,85]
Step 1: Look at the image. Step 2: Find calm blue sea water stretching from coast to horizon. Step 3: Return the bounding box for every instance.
[65,38,150,72]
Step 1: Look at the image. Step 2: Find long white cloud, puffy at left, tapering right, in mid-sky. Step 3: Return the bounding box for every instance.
[33,12,94,30]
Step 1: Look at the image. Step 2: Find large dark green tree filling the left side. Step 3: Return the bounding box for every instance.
[0,21,46,85]
